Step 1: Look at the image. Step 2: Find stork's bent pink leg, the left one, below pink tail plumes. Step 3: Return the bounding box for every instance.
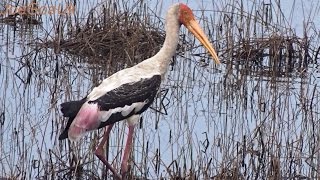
[95,124,121,179]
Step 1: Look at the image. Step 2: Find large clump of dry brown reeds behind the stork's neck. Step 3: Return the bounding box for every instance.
[46,2,165,70]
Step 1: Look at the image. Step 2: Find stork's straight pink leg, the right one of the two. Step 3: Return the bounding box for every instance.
[121,125,135,179]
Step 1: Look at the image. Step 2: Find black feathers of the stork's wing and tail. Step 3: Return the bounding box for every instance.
[59,75,161,140]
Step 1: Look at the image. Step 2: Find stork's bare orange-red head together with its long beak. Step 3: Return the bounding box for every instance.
[178,3,220,64]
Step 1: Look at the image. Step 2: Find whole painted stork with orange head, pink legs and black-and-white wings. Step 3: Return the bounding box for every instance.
[59,3,220,179]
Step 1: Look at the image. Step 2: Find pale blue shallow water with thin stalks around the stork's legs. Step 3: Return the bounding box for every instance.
[0,1,320,179]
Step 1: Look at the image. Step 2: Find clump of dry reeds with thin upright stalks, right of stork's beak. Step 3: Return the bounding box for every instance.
[212,0,317,77]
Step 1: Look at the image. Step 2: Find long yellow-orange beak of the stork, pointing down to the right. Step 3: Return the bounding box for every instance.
[185,19,220,64]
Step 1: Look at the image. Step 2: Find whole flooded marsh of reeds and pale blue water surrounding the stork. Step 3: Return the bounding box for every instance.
[0,0,320,179]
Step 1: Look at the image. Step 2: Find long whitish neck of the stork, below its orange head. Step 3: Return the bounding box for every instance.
[140,4,180,75]
